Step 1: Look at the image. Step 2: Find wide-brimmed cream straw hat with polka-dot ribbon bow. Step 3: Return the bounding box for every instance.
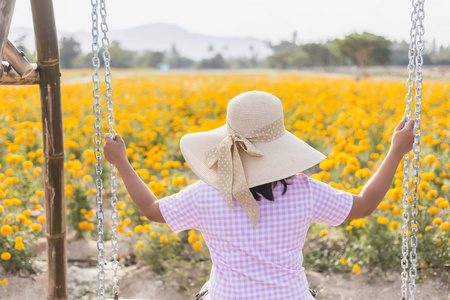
[180,91,326,226]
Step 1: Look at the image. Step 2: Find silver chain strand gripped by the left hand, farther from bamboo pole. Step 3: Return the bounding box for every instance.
[100,0,119,299]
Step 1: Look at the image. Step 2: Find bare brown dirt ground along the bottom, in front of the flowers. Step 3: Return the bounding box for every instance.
[0,265,450,300]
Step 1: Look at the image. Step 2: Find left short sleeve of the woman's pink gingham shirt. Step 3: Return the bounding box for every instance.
[159,183,199,233]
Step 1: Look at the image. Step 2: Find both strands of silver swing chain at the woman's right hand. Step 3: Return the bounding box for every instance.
[401,0,425,300]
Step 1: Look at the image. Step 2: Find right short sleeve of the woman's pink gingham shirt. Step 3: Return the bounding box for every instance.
[309,178,353,226]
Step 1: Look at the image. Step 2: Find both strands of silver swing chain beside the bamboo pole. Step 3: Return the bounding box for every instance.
[91,0,119,300]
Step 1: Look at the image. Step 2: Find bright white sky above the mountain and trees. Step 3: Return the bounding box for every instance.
[7,0,450,46]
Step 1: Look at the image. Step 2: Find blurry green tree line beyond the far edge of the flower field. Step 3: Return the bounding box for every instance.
[18,32,450,76]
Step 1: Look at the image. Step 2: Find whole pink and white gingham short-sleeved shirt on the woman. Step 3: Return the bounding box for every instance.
[160,174,353,300]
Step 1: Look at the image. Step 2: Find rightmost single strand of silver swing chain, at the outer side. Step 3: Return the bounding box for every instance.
[409,0,425,300]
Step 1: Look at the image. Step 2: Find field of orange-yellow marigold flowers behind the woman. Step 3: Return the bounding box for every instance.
[0,72,450,284]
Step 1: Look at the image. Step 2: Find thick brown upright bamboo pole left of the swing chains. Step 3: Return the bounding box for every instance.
[31,0,68,300]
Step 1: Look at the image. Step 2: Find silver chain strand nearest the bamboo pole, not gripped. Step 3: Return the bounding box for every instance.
[91,0,105,300]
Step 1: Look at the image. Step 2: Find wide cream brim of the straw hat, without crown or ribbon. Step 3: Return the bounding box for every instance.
[180,125,326,189]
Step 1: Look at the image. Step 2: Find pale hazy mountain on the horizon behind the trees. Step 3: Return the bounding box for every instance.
[9,23,272,60]
